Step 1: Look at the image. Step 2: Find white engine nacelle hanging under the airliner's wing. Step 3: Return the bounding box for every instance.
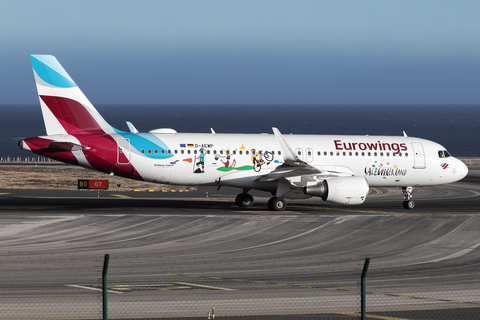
[304,177,370,205]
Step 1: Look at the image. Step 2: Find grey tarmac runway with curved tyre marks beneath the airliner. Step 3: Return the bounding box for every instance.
[0,168,480,319]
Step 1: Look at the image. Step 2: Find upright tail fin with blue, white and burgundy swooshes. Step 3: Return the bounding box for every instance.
[30,55,119,135]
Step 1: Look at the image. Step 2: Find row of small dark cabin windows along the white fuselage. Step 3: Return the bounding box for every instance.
[141,148,408,158]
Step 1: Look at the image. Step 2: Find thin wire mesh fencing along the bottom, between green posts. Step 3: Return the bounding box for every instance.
[0,255,480,320]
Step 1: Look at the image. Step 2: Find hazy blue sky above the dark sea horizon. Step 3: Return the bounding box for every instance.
[0,0,480,104]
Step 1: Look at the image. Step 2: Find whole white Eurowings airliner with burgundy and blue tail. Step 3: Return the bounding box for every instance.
[19,55,468,211]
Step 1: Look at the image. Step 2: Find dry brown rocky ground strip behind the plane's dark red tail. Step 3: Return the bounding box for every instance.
[0,165,192,191]
